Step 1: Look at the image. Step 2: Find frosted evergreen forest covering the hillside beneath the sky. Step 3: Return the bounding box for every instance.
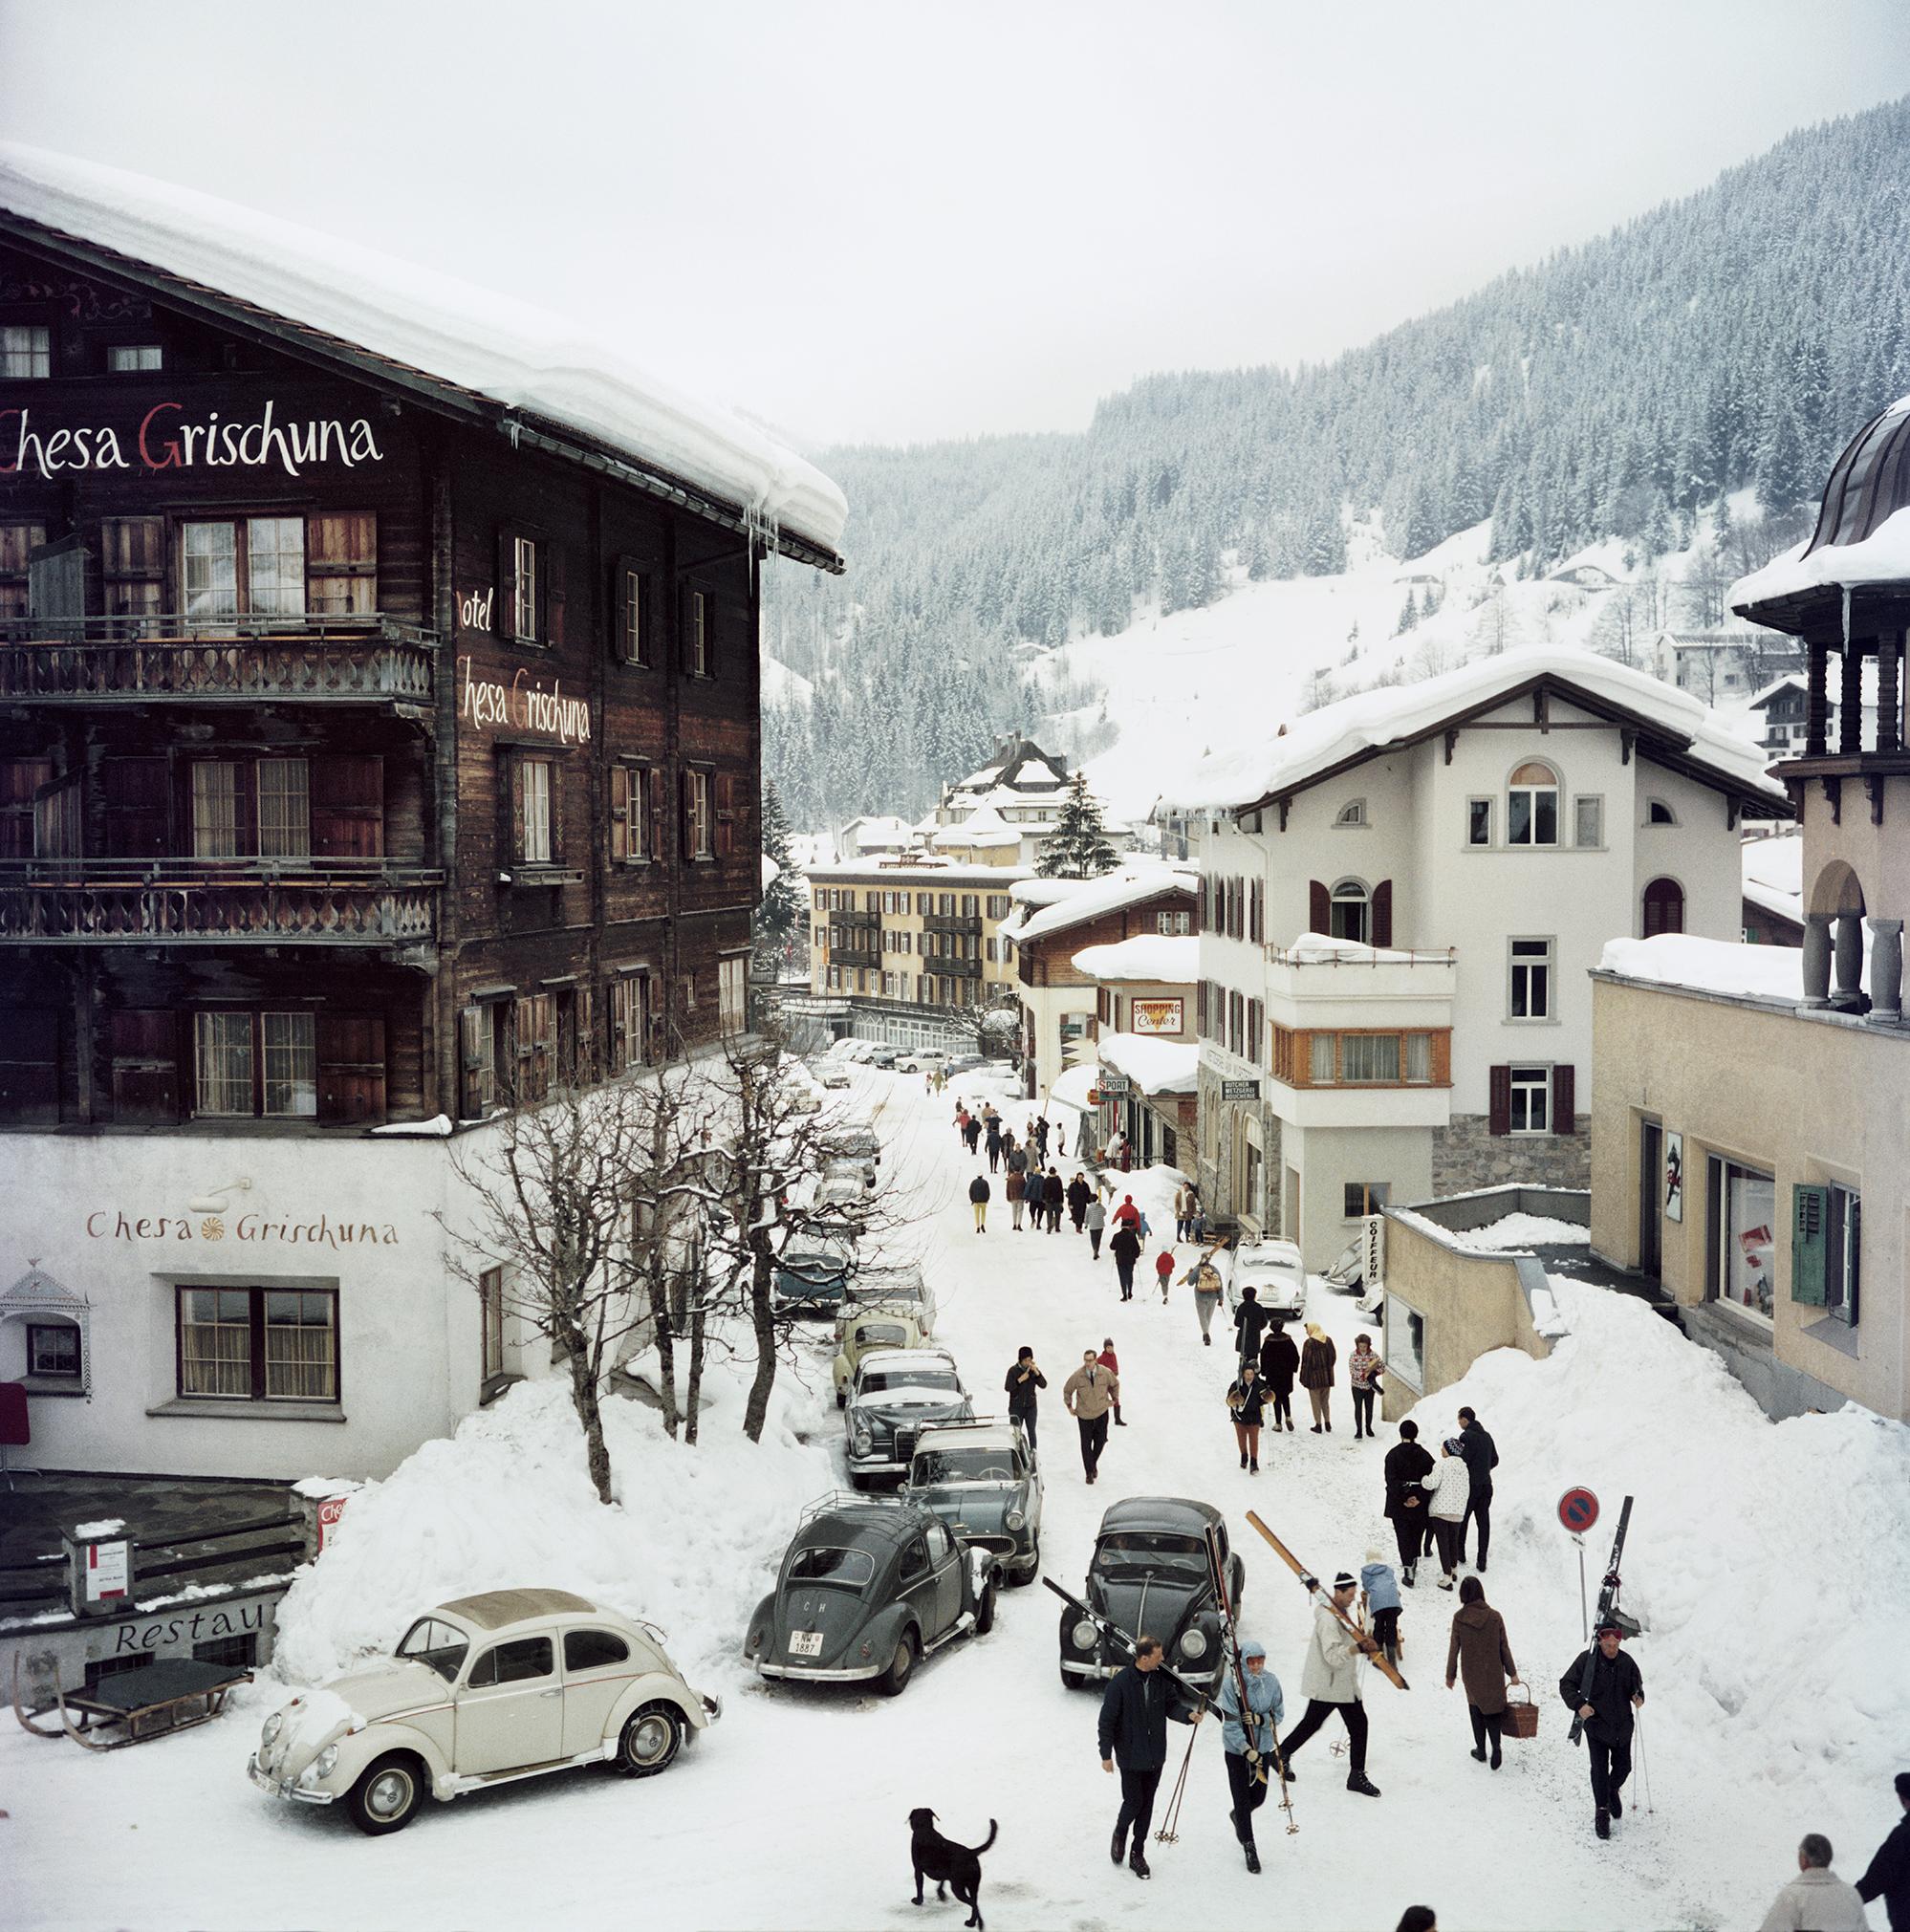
[763,100,1910,827]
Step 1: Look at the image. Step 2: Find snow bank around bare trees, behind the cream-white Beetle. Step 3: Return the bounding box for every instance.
[274,1364,836,1688]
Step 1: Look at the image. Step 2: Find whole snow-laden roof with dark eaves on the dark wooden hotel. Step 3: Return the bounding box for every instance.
[0,141,848,570]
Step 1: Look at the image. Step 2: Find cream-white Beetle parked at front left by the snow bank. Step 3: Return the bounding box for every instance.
[246,1590,723,1835]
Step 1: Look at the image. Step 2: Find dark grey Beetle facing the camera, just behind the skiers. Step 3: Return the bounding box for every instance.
[1060,1495,1246,1688]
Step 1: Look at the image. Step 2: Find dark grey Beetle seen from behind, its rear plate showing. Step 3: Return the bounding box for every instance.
[744,1497,1000,1696]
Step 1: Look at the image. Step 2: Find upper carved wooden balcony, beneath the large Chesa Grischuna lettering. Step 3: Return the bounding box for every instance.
[0,617,437,711]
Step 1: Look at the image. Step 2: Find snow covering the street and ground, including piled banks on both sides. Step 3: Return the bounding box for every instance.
[0,1067,1910,1932]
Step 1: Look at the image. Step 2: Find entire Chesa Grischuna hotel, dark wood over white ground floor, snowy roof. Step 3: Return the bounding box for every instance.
[0,155,840,1476]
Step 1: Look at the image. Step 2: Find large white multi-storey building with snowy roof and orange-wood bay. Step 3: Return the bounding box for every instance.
[1166,649,1789,1268]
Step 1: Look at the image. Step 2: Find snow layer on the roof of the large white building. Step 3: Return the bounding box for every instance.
[1162,645,1789,812]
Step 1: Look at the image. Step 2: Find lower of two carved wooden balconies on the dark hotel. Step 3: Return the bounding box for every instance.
[0,859,445,950]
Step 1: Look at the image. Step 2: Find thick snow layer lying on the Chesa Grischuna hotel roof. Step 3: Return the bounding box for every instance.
[0,141,848,560]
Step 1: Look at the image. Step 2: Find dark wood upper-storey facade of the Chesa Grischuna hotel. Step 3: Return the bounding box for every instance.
[0,216,792,1130]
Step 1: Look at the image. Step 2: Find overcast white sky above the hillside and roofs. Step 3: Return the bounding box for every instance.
[0,0,1910,445]
